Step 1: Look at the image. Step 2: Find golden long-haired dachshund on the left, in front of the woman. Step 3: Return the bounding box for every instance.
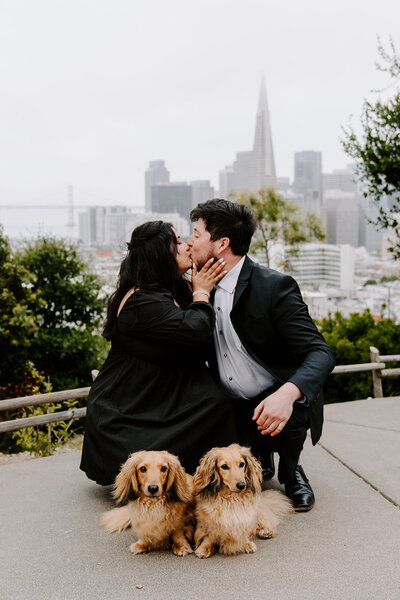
[101,451,194,556]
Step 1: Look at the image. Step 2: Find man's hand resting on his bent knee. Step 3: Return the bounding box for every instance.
[253,382,303,437]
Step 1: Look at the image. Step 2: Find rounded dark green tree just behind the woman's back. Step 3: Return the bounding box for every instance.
[15,237,106,390]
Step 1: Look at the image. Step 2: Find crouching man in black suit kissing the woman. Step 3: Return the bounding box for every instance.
[188,200,335,511]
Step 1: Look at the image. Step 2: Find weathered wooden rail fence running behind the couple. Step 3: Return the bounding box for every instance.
[0,346,400,433]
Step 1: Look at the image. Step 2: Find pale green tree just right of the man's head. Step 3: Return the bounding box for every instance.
[235,188,325,267]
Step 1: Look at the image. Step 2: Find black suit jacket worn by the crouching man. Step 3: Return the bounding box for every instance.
[210,256,335,444]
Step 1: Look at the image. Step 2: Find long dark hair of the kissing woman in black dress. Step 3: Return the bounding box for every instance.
[103,221,191,340]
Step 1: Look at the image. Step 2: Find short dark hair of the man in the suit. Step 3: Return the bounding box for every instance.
[190,198,256,256]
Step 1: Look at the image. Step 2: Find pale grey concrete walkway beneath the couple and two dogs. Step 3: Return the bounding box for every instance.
[0,397,400,600]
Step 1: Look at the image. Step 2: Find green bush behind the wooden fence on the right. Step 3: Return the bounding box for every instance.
[319,310,400,403]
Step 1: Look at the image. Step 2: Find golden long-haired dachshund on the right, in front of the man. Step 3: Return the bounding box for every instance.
[194,444,292,558]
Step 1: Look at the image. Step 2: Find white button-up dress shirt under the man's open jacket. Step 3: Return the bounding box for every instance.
[214,256,275,398]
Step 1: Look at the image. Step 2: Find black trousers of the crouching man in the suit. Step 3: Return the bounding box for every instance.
[234,390,310,483]
